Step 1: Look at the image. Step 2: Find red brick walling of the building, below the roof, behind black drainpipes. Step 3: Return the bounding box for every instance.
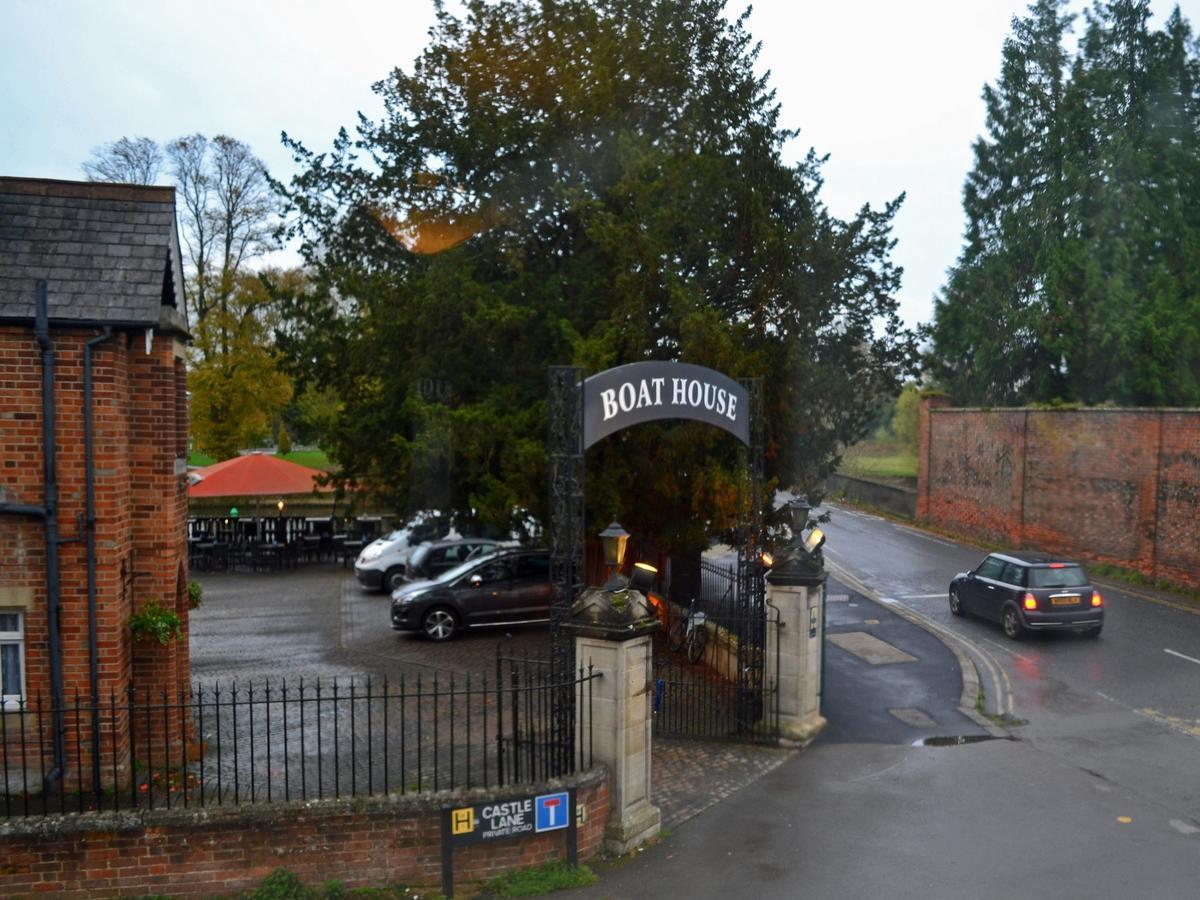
[0,325,187,782]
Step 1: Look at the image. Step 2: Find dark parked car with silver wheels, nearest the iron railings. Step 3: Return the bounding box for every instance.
[391,550,553,641]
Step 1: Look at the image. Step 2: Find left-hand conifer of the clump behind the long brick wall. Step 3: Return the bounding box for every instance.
[934,0,1072,404]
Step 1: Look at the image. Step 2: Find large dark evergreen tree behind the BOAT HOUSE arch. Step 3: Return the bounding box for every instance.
[283,0,914,548]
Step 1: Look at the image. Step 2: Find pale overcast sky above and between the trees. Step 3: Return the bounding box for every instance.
[0,0,1200,325]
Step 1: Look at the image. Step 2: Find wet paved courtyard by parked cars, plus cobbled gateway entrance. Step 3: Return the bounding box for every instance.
[191,564,796,828]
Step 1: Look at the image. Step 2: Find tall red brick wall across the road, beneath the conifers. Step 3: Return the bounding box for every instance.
[917,397,1200,587]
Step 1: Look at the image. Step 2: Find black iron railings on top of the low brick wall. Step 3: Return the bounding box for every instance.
[0,656,600,817]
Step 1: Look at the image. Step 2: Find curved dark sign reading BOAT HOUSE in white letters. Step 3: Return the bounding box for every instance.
[583,362,750,449]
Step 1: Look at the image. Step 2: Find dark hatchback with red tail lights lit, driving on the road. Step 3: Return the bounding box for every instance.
[950,552,1104,641]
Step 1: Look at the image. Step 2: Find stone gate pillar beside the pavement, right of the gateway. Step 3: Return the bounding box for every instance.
[766,565,828,740]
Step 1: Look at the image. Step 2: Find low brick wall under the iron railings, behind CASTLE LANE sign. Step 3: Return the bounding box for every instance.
[0,768,608,898]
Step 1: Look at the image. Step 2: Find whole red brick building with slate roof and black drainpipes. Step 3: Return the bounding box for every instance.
[0,178,188,782]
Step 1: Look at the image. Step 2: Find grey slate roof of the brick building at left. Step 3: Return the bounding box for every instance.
[0,176,187,337]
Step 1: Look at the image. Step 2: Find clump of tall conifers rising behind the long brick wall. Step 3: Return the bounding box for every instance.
[931,0,1200,404]
